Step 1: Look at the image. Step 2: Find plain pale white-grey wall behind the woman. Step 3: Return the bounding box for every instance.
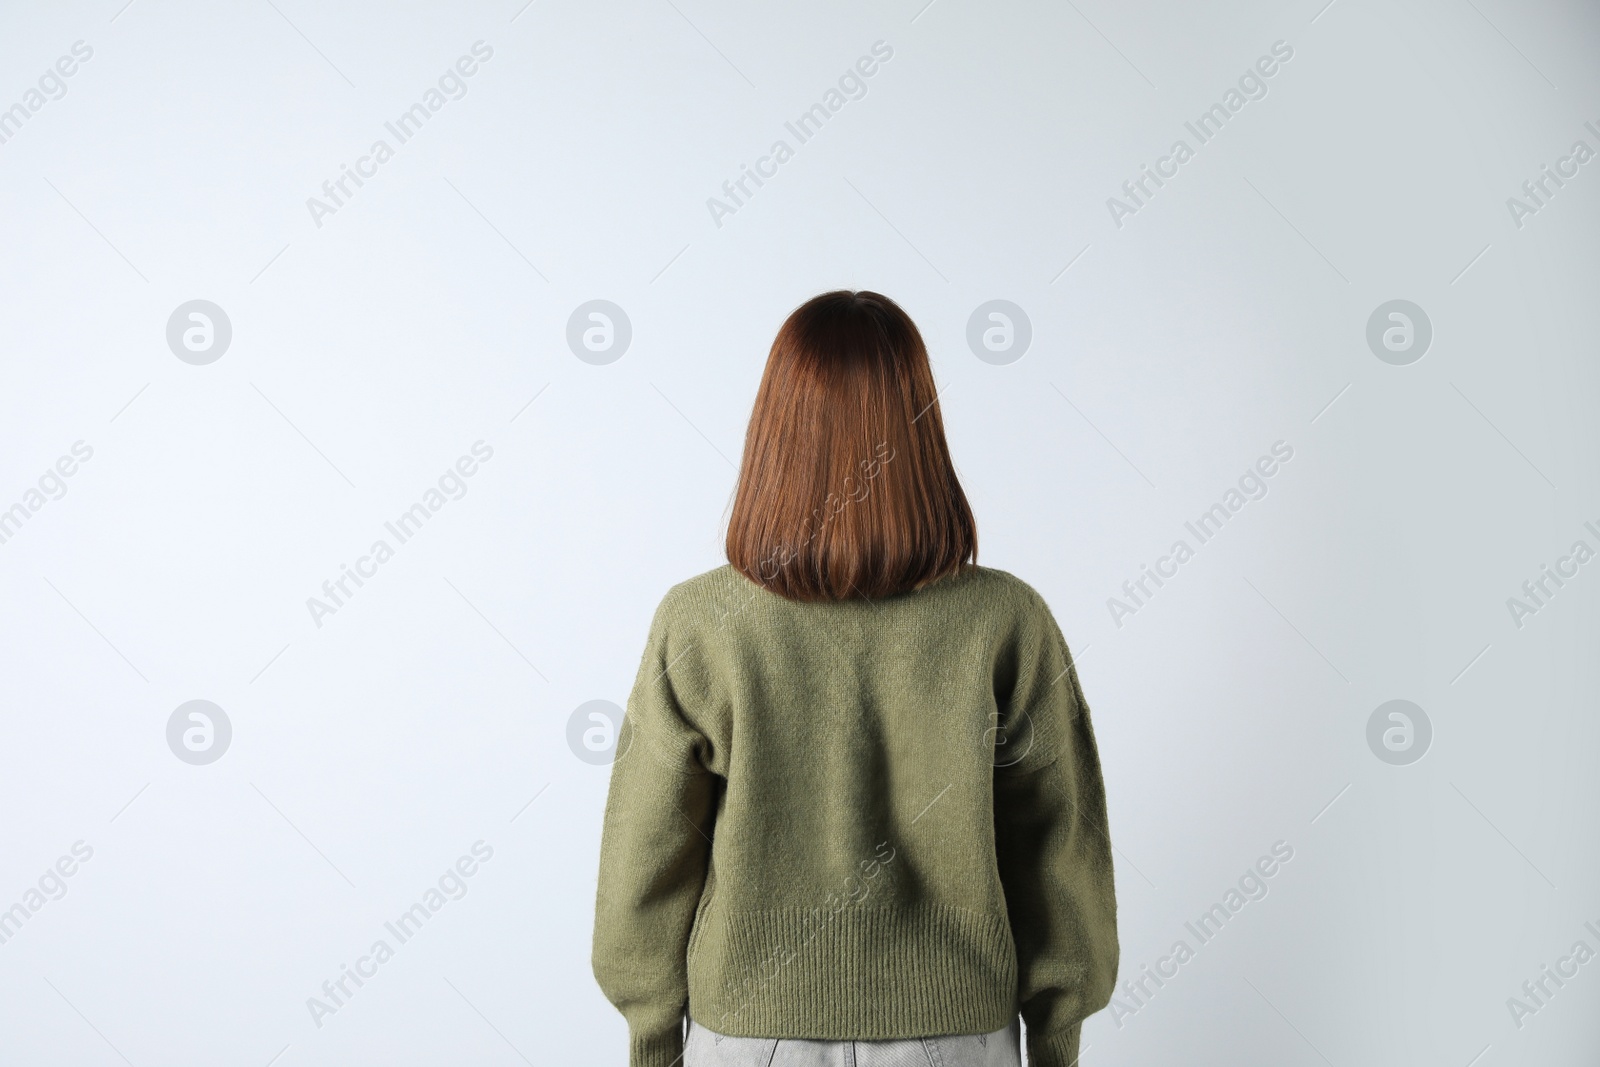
[0,0,1600,1067]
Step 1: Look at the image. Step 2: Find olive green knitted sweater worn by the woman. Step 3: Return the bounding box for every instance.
[592,565,1117,1067]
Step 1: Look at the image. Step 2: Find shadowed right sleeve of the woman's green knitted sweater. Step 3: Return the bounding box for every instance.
[995,600,1118,1067]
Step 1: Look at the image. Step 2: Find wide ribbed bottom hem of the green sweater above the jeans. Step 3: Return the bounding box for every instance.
[688,904,1016,1041]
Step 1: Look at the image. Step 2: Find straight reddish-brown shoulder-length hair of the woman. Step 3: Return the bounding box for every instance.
[726,290,978,600]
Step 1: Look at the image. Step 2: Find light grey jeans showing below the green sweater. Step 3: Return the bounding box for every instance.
[683,1019,1022,1067]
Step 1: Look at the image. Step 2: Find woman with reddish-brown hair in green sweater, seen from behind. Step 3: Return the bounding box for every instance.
[594,291,1117,1067]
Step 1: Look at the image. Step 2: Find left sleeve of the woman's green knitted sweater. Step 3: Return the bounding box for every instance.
[592,600,715,1067]
